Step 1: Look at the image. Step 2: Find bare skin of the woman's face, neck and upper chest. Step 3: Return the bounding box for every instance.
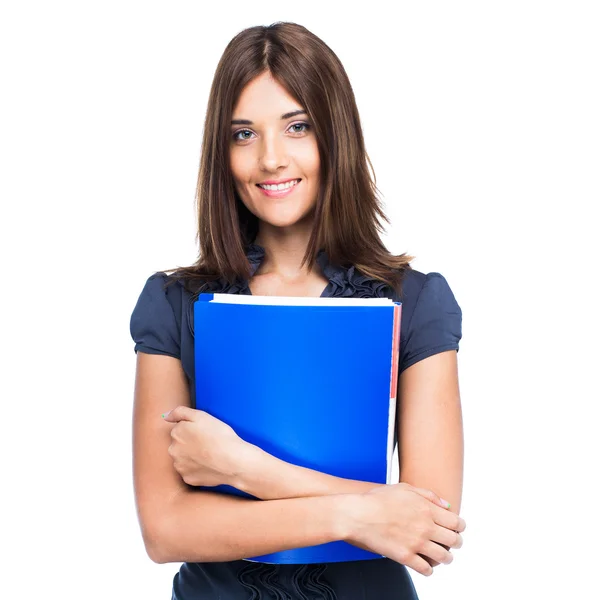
[230,72,327,296]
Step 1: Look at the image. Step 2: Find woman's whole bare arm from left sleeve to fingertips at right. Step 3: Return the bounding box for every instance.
[133,351,464,575]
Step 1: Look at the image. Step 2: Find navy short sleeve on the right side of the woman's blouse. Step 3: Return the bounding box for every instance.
[400,273,462,372]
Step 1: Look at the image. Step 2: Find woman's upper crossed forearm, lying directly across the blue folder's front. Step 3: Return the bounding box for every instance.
[232,445,385,500]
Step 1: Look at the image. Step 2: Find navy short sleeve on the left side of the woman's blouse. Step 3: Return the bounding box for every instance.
[129,273,181,358]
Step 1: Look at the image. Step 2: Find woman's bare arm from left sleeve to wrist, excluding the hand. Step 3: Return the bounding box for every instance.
[133,352,347,563]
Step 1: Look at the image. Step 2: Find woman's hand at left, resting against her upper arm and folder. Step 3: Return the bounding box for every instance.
[164,406,249,486]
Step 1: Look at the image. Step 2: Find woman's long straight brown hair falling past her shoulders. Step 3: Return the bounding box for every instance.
[172,22,412,291]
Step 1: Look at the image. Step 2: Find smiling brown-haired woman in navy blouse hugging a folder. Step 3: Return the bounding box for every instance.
[131,23,465,600]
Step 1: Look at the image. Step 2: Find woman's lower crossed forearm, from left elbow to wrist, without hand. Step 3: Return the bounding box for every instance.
[149,491,353,563]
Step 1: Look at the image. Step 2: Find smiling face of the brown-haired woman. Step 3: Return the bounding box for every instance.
[230,72,320,227]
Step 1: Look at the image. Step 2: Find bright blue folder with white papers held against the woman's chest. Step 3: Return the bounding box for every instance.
[194,294,400,564]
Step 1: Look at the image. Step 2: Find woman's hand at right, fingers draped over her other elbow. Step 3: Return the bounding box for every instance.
[345,483,466,576]
